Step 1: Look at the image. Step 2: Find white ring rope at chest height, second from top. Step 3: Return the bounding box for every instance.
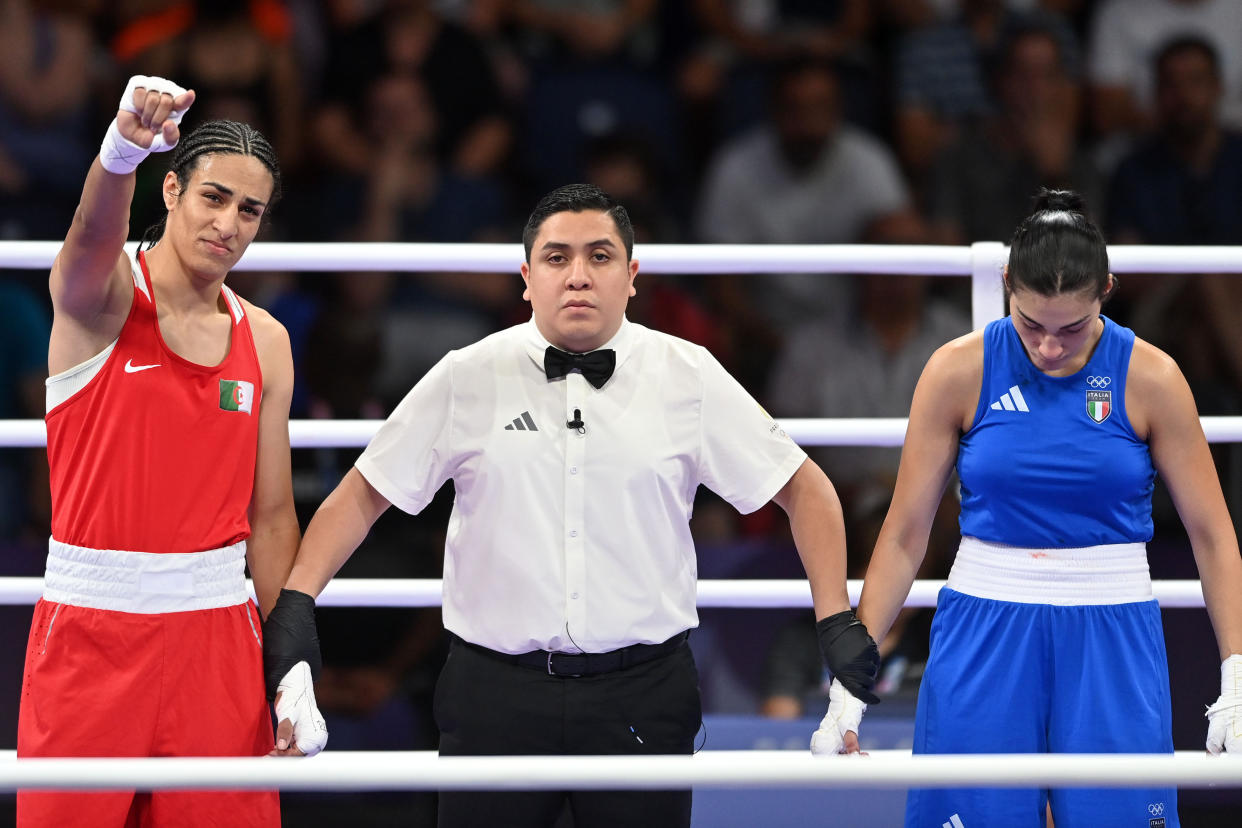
[0,417,1242,448]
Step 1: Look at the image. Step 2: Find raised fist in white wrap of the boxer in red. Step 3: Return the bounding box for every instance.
[99,74,194,175]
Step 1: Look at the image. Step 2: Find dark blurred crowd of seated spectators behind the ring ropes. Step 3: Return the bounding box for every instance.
[0,0,1242,769]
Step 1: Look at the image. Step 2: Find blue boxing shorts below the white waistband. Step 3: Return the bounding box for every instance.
[905,587,1179,828]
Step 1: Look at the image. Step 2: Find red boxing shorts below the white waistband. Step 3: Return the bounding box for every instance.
[17,600,281,828]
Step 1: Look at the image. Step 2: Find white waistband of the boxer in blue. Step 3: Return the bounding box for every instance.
[945,538,1153,606]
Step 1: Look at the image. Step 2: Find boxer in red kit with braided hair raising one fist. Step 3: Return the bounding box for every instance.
[17,77,327,827]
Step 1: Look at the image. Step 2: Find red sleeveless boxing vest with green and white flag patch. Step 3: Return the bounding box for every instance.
[46,253,263,552]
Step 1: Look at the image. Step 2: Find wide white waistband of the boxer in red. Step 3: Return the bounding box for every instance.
[43,538,250,614]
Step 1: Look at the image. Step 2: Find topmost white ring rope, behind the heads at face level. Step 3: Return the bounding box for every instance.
[7,241,1242,276]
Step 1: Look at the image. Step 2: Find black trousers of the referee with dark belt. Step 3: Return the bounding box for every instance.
[435,641,703,828]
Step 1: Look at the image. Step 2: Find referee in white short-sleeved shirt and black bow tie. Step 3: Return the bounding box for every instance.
[265,184,878,828]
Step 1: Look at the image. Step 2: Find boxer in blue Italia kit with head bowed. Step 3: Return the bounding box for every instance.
[837,191,1242,828]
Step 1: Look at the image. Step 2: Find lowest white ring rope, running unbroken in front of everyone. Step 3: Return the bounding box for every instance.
[0,750,1242,792]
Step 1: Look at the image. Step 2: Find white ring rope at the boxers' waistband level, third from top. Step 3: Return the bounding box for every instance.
[0,577,1203,610]
